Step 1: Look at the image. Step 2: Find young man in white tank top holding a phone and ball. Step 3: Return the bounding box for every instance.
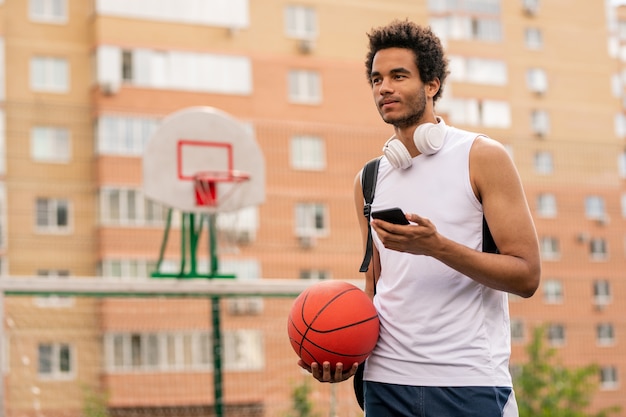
[301,21,540,417]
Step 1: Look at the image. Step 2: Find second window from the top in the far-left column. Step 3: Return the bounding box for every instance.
[30,57,69,93]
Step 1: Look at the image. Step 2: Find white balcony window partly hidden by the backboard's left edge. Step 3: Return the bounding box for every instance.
[96,115,159,156]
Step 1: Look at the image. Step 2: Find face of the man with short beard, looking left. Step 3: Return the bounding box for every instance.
[370,48,426,128]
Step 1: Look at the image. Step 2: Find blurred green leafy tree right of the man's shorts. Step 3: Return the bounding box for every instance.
[514,327,620,417]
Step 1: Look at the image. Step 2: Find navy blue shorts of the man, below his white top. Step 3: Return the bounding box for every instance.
[364,381,518,417]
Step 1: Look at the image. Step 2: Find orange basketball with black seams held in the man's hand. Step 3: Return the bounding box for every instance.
[287,281,379,370]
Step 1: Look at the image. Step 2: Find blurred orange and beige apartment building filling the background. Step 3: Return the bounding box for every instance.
[0,0,626,416]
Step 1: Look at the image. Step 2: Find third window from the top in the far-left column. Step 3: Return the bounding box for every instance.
[30,126,71,163]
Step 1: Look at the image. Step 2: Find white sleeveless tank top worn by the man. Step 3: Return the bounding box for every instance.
[364,122,512,387]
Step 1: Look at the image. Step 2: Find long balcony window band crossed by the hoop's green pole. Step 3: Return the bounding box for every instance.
[104,329,265,372]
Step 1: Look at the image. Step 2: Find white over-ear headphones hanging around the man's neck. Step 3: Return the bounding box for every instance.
[383,117,446,169]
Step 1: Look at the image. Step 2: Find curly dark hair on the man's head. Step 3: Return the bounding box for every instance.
[365,19,449,102]
